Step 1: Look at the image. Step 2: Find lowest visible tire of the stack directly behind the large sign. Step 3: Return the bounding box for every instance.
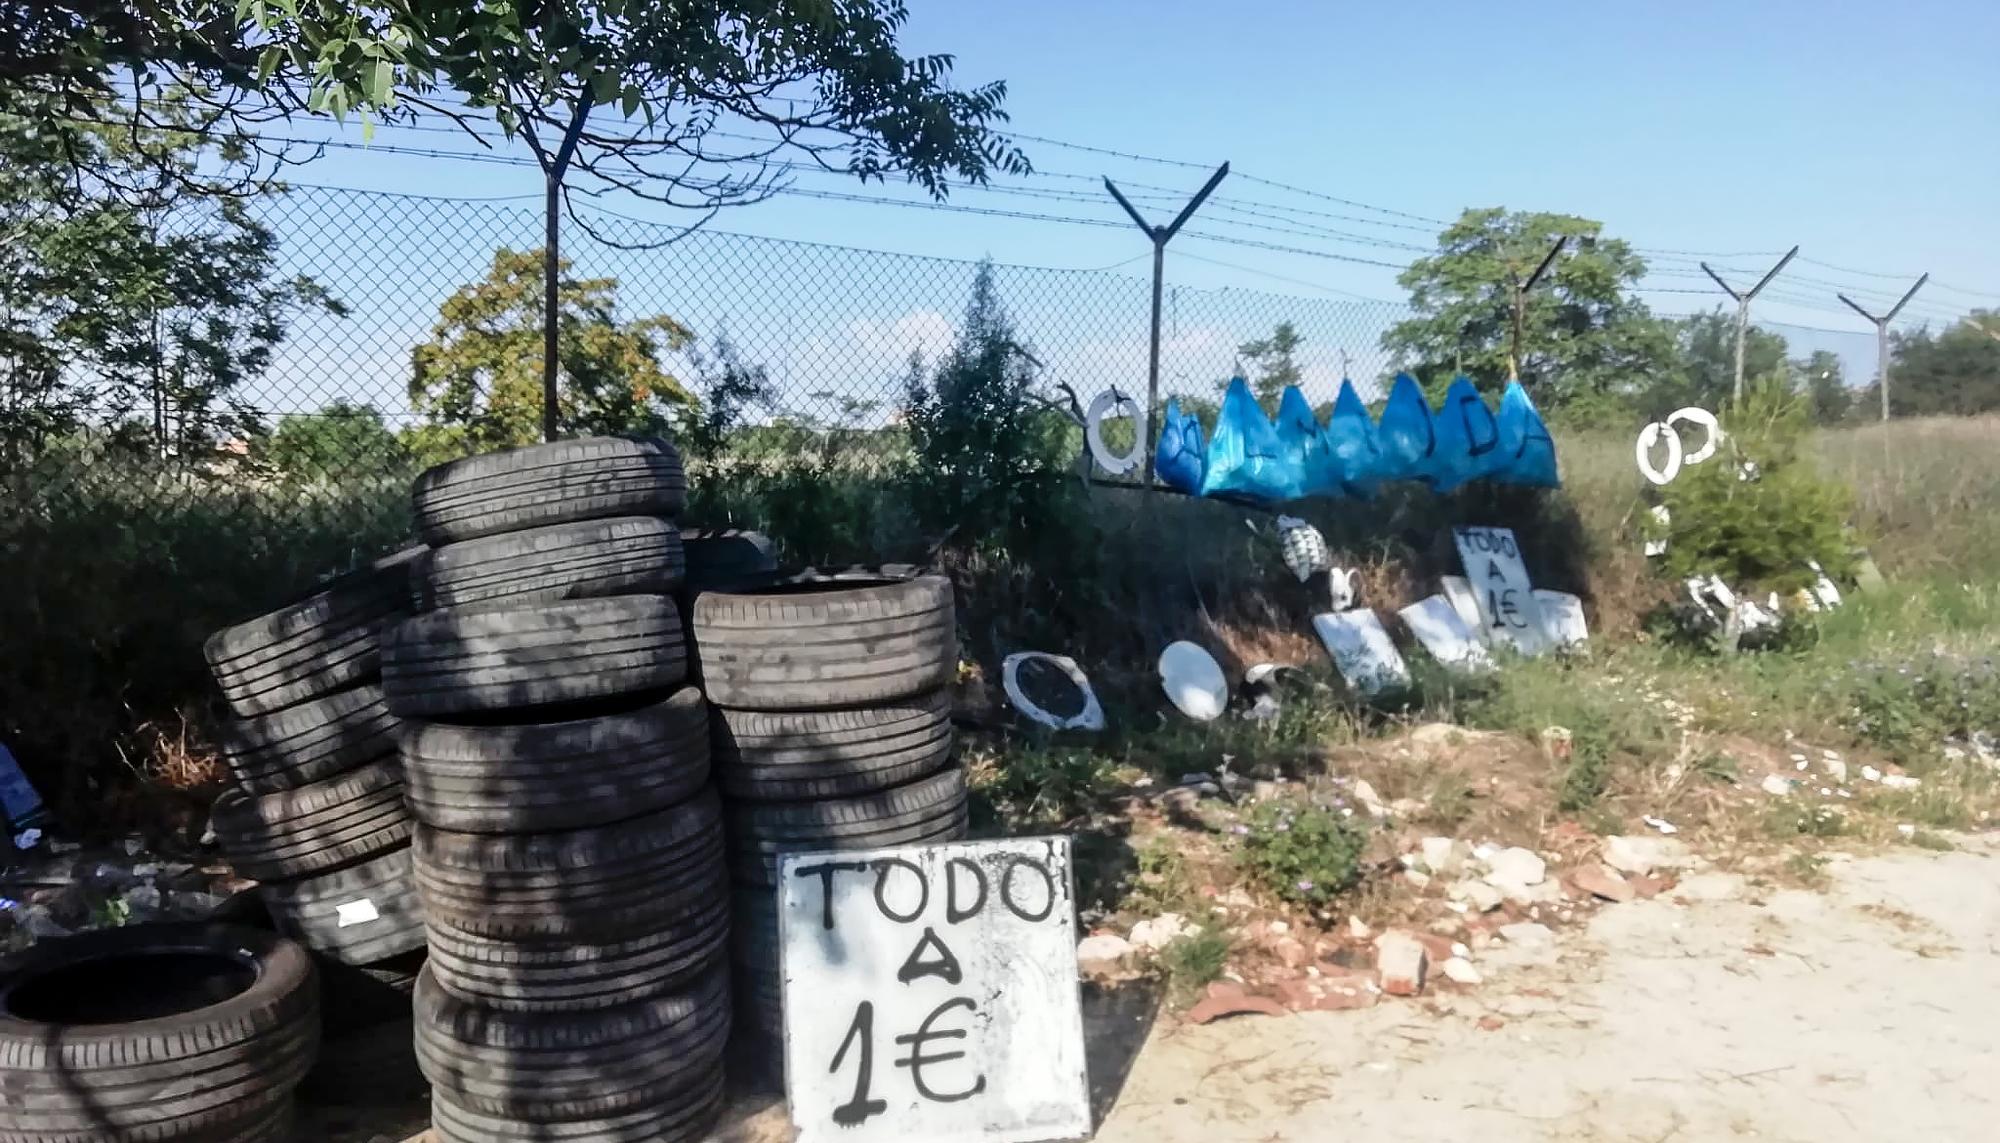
[728,769,966,885]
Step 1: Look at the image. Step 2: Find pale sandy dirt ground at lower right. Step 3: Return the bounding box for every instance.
[338,835,2000,1143]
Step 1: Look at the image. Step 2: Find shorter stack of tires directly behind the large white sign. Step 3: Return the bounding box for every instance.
[694,573,966,1081]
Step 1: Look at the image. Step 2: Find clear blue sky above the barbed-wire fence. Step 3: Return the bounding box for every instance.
[254,0,2000,419]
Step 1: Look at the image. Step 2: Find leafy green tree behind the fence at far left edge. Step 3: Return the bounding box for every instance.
[0,99,346,458]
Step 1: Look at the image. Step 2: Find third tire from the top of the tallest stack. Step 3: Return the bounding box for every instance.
[382,595,688,717]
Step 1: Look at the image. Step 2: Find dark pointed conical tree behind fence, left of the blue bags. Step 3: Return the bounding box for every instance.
[904,262,1072,548]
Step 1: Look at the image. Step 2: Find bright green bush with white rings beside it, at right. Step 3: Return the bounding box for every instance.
[1650,380,1854,593]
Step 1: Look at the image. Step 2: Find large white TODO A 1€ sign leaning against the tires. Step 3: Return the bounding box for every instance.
[778,837,1090,1143]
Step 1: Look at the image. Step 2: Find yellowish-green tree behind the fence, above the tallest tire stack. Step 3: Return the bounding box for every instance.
[410,248,694,456]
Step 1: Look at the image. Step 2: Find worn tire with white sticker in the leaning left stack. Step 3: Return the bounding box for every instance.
[258,845,424,965]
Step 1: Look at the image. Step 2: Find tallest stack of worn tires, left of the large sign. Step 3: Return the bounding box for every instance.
[382,438,730,1143]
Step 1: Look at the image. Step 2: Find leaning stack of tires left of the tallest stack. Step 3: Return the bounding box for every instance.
[204,550,424,1095]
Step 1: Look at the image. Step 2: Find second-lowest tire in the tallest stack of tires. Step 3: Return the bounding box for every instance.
[416,965,730,1123]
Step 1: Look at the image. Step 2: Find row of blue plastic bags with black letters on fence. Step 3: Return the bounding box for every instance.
[1154,374,1562,504]
